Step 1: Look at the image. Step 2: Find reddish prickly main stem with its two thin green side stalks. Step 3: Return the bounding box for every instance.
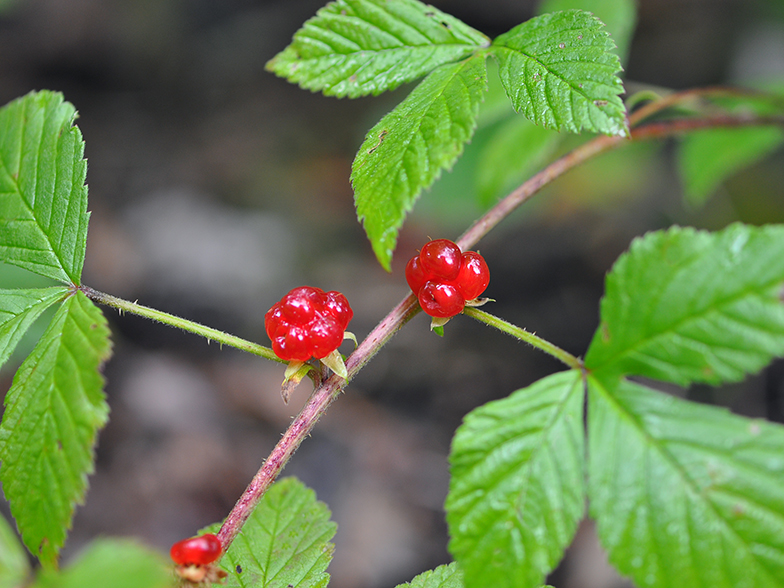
[80,88,784,551]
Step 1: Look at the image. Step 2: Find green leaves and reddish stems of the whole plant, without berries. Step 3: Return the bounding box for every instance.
[0,0,784,588]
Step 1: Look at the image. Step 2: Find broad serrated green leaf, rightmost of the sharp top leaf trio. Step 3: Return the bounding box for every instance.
[490,10,629,136]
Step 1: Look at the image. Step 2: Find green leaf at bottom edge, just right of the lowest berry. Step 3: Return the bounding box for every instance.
[206,478,337,588]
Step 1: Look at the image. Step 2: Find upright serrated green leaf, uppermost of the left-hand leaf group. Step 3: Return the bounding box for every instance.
[0,91,90,285]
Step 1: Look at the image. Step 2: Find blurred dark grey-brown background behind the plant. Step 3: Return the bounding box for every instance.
[0,0,784,588]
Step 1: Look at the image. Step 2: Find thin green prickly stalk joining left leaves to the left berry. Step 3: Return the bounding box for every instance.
[79,286,286,363]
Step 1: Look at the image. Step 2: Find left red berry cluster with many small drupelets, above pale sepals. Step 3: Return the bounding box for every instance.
[264,286,354,361]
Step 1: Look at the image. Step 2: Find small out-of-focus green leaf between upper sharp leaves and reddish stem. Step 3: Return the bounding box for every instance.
[476,116,561,205]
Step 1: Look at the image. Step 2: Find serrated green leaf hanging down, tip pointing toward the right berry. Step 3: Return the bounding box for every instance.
[351,54,487,270]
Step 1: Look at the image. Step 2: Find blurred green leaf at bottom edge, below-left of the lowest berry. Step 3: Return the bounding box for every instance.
[33,539,175,588]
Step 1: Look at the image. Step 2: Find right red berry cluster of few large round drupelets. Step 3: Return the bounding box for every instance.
[406,239,490,318]
